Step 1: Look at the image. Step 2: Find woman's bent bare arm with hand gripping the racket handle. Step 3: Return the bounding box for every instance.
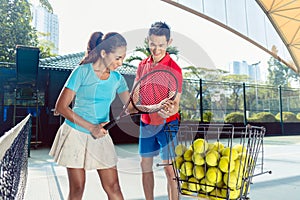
[55,87,107,138]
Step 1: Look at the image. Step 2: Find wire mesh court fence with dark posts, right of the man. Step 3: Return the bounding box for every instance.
[180,79,300,124]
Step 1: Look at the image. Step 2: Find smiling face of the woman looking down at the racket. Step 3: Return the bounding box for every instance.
[101,46,126,71]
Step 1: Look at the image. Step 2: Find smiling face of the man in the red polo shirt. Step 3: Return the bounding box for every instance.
[148,34,171,63]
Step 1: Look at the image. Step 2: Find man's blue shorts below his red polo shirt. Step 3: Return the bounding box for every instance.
[139,120,179,160]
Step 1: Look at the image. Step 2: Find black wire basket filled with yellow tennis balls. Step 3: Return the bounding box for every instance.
[170,124,271,200]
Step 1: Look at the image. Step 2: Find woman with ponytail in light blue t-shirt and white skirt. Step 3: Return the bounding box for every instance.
[49,32,129,200]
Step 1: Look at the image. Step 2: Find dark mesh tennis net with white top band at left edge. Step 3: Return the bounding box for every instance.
[0,115,31,200]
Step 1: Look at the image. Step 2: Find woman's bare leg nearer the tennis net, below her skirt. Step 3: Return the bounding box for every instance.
[67,168,85,200]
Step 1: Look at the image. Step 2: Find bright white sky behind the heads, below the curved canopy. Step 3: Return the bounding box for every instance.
[31,0,271,72]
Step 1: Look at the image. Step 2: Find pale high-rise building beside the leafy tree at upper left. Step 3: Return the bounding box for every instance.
[32,5,59,54]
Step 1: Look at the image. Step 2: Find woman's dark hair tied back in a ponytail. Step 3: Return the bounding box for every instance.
[80,32,127,64]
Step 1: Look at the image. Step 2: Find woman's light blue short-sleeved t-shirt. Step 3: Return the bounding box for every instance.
[65,63,128,133]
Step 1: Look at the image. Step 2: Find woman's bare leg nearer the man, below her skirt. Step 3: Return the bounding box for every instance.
[97,167,124,200]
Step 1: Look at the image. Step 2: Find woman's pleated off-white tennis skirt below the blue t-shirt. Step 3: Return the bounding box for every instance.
[49,123,118,170]
